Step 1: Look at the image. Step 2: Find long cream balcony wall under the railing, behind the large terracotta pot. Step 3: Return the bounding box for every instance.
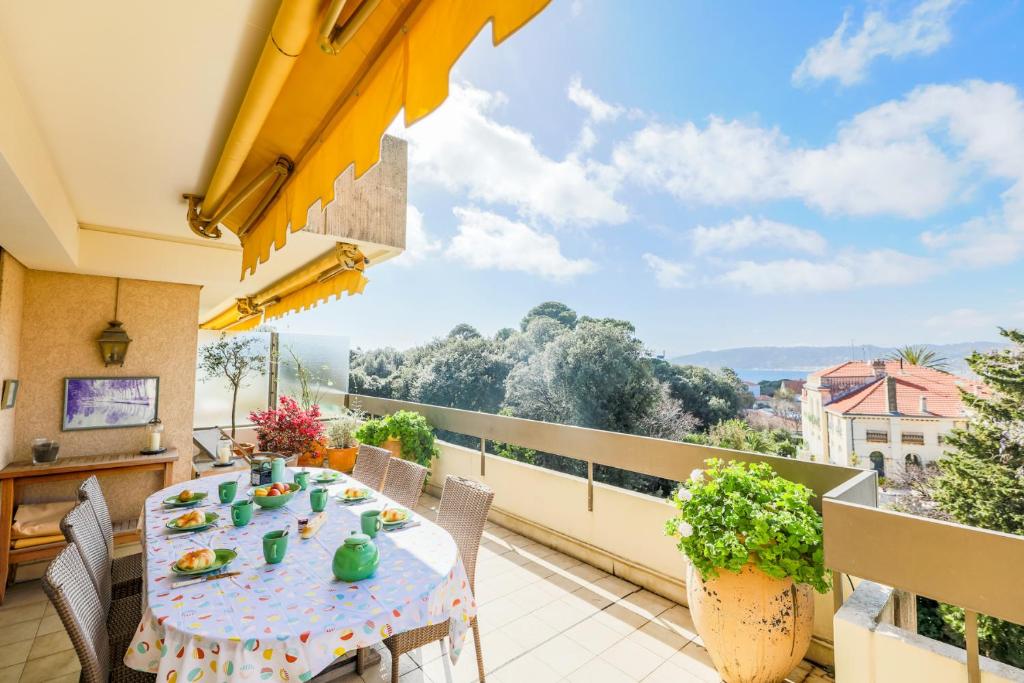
[428,442,833,666]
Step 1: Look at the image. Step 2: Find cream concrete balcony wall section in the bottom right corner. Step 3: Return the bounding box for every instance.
[835,582,1024,683]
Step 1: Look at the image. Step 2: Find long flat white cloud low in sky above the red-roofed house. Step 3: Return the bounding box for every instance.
[721,249,936,294]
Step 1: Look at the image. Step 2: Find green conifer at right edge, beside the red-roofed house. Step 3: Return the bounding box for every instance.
[934,330,1024,667]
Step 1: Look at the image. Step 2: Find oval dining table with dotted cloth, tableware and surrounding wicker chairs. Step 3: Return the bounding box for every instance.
[36,445,494,683]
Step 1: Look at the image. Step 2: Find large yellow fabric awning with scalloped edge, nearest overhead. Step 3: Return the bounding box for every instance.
[205,0,550,278]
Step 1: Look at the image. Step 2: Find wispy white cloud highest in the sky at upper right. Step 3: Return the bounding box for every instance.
[793,0,957,85]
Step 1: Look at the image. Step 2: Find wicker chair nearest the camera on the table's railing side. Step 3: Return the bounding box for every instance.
[368,475,495,683]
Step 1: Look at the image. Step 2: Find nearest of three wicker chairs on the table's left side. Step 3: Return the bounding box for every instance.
[43,543,157,683]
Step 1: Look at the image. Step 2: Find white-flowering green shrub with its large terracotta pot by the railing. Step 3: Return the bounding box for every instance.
[666,460,829,683]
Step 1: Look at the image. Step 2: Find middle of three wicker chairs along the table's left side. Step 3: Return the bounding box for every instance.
[60,501,142,645]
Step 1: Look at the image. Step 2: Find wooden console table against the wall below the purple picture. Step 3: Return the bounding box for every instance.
[0,449,178,604]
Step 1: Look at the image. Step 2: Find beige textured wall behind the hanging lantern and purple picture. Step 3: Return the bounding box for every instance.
[14,270,200,479]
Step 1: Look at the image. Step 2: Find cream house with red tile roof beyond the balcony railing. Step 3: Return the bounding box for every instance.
[801,359,984,476]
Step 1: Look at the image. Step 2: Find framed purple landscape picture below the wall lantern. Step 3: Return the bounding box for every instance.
[60,377,160,431]
